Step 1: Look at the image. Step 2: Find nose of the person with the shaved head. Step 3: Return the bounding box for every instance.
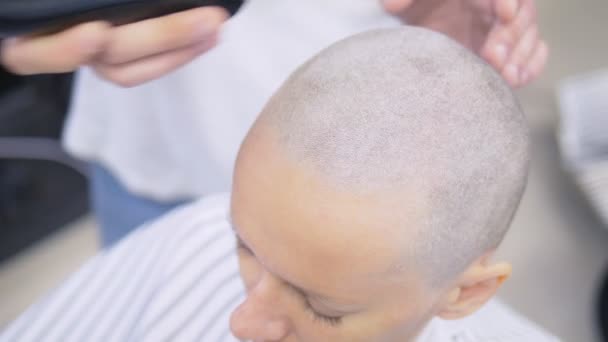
[230,276,289,341]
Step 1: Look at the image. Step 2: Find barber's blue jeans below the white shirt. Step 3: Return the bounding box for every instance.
[90,164,186,248]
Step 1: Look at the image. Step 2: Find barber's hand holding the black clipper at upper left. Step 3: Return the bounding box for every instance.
[0,7,228,87]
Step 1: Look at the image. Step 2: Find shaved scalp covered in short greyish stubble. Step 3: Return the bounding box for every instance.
[238,27,529,283]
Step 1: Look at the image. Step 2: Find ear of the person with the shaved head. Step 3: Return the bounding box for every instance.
[437,261,512,320]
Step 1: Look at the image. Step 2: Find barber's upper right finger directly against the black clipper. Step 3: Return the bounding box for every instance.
[100,6,228,68]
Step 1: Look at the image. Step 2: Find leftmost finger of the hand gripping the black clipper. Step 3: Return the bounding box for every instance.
[0,22,111,75]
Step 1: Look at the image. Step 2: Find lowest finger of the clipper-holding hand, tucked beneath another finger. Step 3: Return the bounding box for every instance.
[92,36,217,87]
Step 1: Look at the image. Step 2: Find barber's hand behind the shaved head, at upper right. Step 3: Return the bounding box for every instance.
[382,0,549,87]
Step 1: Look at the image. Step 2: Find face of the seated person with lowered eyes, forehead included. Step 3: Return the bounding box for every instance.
[231,132,439,342]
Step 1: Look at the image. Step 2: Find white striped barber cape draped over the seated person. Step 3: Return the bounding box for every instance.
[0,195,558,342]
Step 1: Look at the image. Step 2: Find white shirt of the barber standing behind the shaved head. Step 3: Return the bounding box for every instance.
[64,0,400,200]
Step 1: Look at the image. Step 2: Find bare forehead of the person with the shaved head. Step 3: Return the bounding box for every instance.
[232,134,426,296]
